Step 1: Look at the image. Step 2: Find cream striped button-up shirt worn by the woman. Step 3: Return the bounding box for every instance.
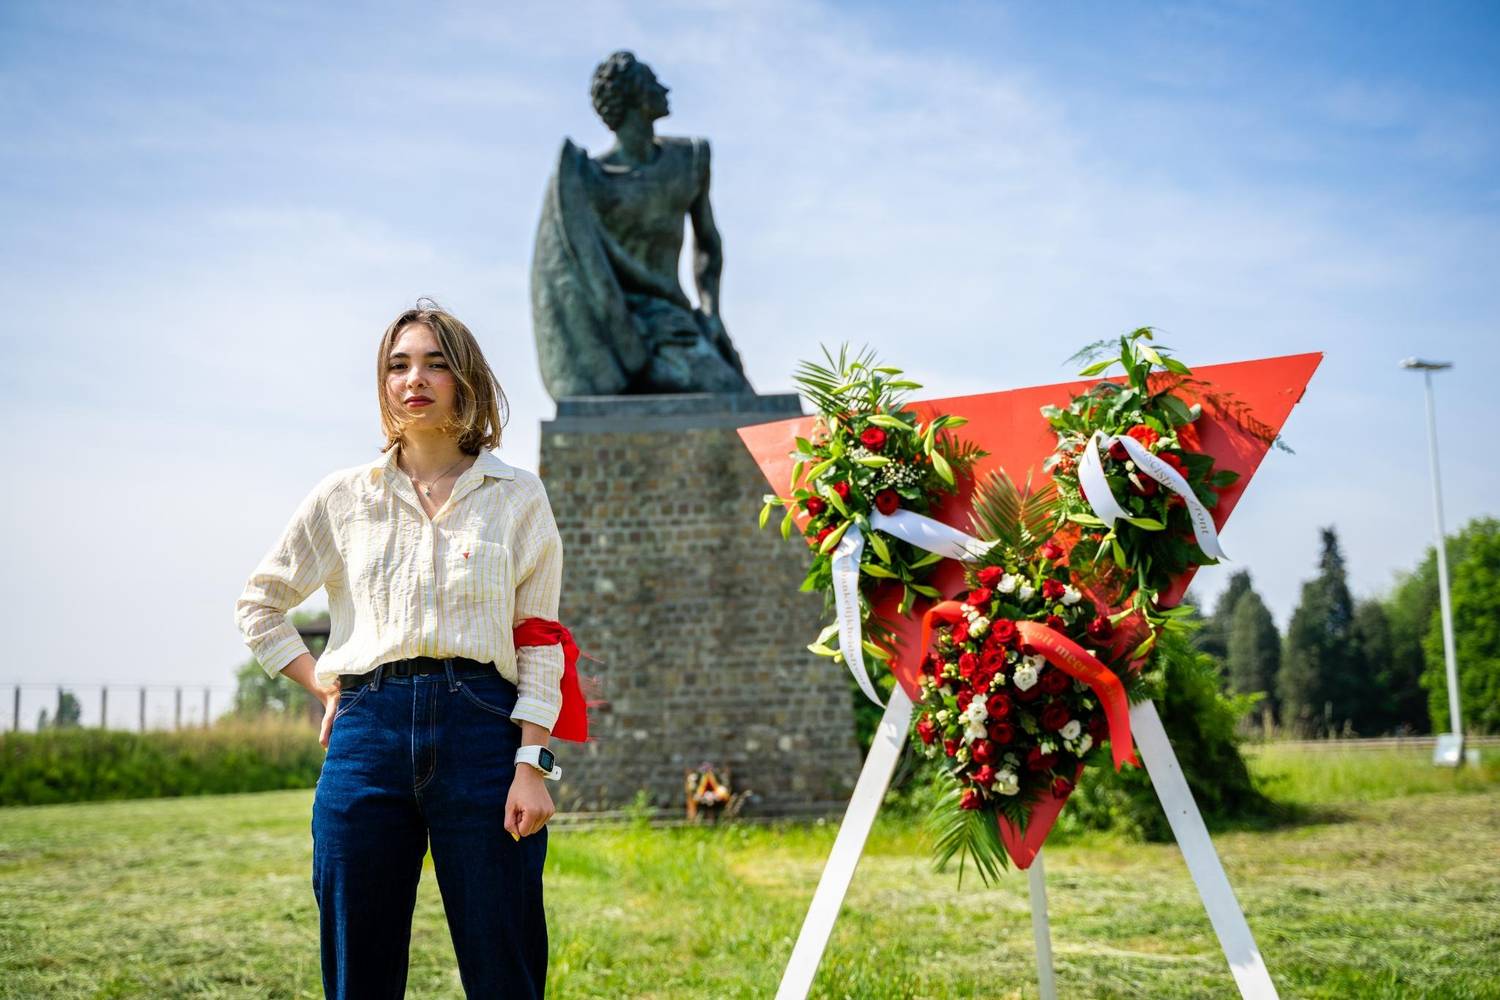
[234,448,563,730]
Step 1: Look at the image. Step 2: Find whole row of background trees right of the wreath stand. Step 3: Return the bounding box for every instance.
[1196,517,1500,736]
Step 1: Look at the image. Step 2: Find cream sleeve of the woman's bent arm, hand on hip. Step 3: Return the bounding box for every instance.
[234,483,336,678]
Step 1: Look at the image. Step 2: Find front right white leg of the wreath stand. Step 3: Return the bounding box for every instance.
[1130,702,1277,1000]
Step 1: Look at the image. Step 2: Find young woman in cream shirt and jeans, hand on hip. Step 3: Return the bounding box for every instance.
[236,303,564,1000]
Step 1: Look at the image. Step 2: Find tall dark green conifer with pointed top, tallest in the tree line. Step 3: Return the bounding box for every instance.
[1277,528,1365,736]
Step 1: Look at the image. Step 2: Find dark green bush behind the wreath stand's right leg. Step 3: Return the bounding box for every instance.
[1062,630,1280,841]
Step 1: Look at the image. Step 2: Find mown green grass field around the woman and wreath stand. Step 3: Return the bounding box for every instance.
[0,748,1500,1000]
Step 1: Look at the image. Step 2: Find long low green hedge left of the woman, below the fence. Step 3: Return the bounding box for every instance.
[0,717,324,807]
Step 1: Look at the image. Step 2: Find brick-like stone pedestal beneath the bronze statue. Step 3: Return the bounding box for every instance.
[542,394,860,816]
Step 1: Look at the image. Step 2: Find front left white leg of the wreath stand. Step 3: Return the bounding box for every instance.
[776,685,912,1000]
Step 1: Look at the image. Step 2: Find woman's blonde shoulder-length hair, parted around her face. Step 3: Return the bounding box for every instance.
[375,298,510,454]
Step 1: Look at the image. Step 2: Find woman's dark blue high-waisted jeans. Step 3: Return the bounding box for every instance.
[312,663,548,1000]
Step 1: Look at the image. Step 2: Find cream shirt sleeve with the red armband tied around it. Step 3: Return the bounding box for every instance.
[510,480,563,730]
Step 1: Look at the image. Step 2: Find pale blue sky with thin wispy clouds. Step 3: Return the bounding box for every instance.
[0,0,1500,717]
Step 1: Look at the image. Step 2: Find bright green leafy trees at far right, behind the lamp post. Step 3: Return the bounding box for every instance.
[1422,519,1500,733]
